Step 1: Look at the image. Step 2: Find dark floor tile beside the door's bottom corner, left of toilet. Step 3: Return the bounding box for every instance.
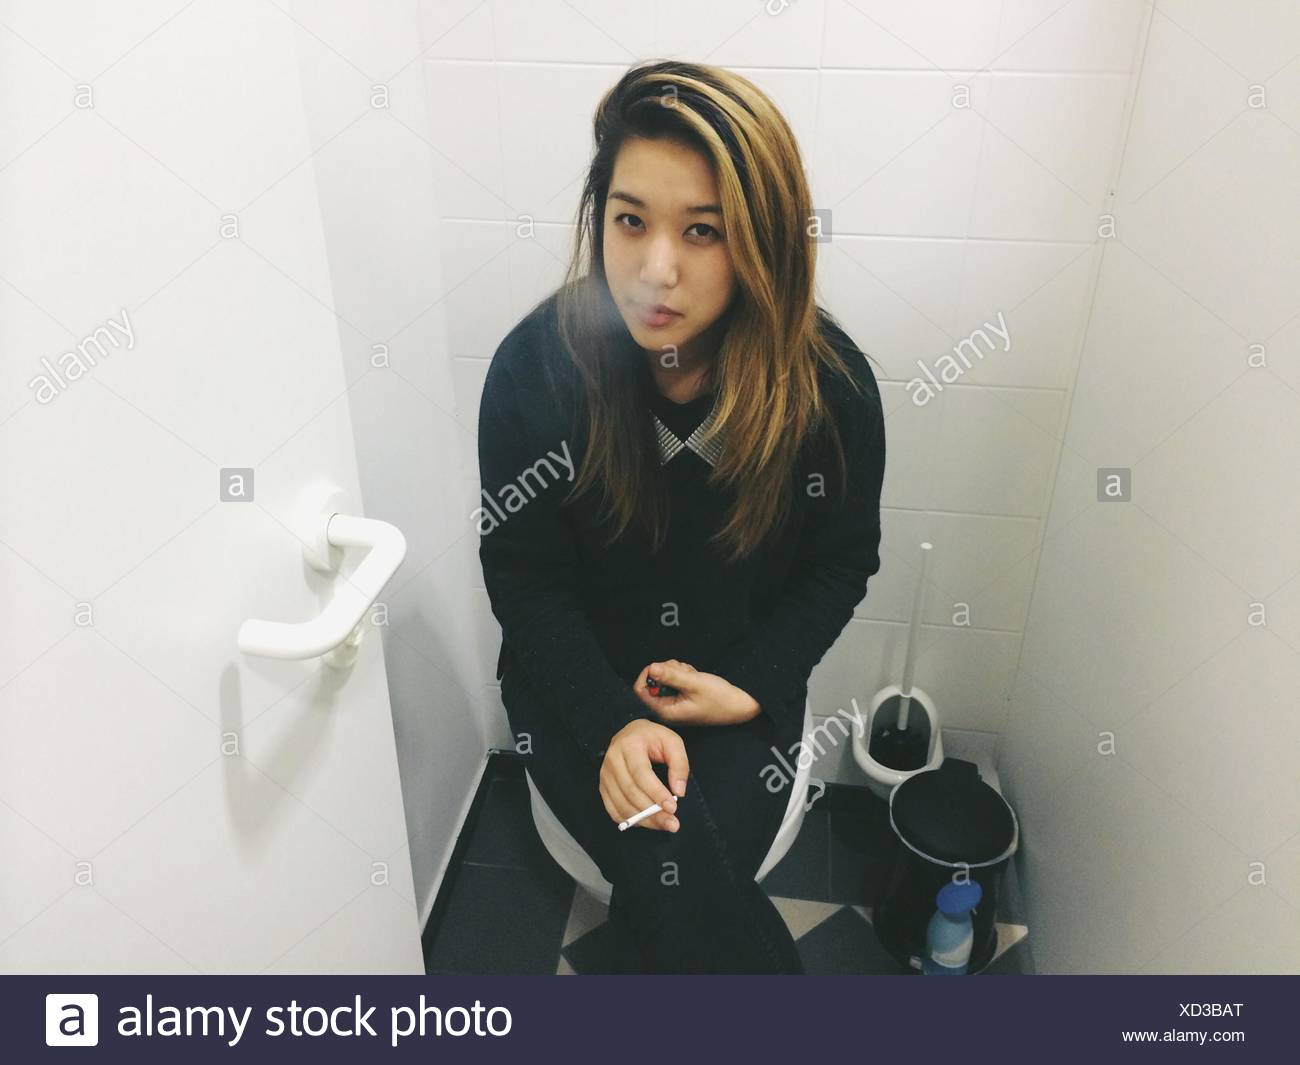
[425,863,575,974]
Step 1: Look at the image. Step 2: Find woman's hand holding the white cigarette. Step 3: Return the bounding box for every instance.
[601,718,690,832]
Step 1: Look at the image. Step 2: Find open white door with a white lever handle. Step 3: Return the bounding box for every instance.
[0,8,423,974]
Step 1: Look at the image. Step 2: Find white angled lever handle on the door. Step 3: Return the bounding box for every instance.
[237,484,406,667]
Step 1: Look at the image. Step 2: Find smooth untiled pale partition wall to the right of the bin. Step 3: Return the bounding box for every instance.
[1000,0,1300,973]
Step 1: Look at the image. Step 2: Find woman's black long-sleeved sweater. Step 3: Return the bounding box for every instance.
[473,295,885,762]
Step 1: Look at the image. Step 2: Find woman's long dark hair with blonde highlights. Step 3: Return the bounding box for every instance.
[535,61,873,562]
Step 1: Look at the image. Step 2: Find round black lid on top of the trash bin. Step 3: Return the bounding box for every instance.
[889,758,1015,866]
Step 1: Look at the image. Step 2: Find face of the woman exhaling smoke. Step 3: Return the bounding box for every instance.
[603,137,736,363]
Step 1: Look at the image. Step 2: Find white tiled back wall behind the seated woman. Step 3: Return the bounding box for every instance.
[444,0,1143,783]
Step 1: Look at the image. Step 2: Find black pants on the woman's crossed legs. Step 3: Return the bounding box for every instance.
[502,668,803,974]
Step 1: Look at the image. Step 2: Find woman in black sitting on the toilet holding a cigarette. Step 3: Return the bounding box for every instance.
[476,62,885,973]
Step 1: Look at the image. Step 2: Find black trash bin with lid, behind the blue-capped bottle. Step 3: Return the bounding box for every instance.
[872,758,1019,974]
